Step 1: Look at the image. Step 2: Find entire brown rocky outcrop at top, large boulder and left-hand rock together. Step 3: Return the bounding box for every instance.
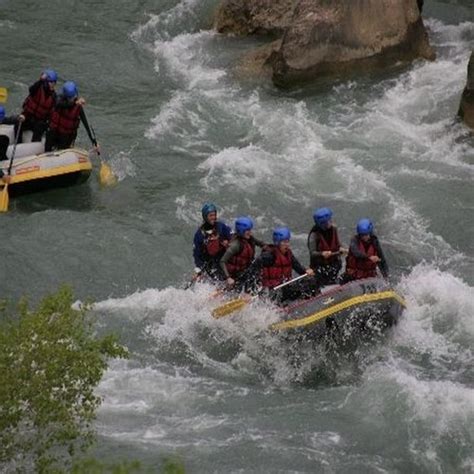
[215,0,435,86]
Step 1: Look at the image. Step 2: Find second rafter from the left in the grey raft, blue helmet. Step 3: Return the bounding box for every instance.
[219,217,266,292]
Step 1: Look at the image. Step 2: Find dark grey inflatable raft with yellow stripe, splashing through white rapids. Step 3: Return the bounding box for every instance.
[270,278,405,337]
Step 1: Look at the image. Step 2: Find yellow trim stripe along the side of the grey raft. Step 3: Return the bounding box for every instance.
[270,290,406,331]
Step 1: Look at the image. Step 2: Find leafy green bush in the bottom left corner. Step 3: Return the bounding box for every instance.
[0,287,128,472]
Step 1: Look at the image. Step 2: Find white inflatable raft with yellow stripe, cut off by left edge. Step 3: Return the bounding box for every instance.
[0,125,92,196]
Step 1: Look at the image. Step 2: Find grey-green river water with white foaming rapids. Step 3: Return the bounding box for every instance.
[0,0,474,473]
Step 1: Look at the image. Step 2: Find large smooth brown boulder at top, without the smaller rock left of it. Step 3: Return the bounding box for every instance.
[269,0,435,86]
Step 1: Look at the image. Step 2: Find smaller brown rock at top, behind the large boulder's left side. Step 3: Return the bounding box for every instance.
[214,0,298,37]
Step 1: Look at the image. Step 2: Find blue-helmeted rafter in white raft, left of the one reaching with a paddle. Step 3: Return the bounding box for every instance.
[15,69,58,143]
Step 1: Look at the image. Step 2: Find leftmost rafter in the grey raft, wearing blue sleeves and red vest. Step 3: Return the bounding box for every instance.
[193,202,232,281]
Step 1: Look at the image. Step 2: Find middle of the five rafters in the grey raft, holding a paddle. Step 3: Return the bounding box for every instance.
[258,227,319,303]
